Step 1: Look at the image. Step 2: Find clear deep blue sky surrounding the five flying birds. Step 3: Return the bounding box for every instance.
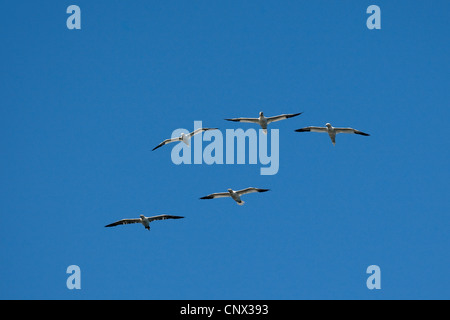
[0,0,450,299]
